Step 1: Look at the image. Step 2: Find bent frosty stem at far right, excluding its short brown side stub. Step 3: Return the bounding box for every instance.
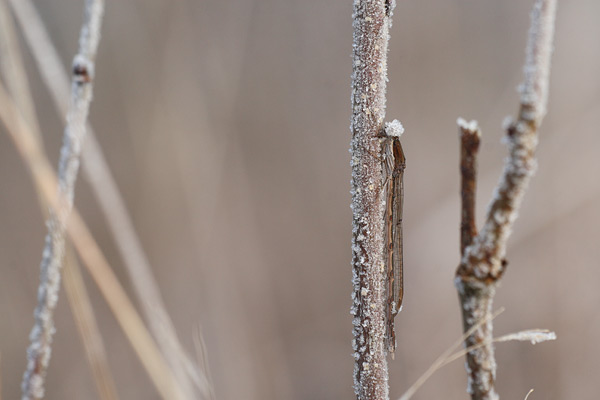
[455,0,556,400]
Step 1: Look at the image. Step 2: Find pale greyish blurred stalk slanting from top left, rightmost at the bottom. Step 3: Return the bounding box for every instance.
[9,0,212,398]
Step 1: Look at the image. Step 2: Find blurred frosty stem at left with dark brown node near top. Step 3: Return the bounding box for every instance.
[22,0,104,400]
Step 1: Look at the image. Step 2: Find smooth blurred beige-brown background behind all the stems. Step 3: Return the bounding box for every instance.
[0,0,600,399]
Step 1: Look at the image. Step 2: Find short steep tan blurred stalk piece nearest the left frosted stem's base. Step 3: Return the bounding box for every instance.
[64,247,119,400]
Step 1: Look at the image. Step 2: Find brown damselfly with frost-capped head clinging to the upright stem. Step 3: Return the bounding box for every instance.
[382,121,406,357]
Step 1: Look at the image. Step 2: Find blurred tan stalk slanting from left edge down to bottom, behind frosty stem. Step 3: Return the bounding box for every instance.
[0,85,186,400]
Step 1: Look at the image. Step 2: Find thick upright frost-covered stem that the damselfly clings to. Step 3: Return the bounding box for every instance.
[350,0,394,399]
